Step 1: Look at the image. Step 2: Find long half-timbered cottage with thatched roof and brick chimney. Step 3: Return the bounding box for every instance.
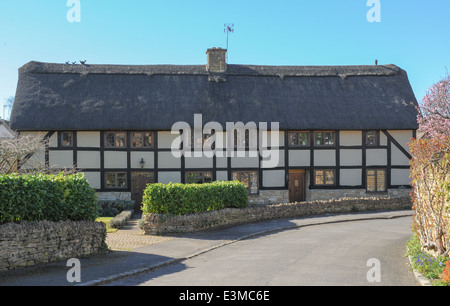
[11,49,417,208]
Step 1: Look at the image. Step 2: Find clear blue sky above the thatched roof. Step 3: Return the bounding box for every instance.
[0,0,450,116]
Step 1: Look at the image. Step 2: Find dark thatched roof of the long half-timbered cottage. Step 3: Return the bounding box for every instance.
[11,62,417,130]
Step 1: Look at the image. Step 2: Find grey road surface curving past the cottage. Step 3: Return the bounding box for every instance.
[109,217,418,286]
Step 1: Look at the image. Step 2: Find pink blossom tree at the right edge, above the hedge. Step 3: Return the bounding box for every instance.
[417,73,450,138]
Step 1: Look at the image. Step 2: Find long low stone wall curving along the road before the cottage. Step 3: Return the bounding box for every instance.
[143,197,412,235]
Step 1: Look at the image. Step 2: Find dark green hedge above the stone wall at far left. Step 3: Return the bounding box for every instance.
[0,173,98,223]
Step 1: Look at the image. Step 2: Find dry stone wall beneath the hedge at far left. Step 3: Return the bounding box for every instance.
[0,221,106,271]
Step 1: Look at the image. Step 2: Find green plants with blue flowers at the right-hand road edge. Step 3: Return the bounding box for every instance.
[406,234,450,286]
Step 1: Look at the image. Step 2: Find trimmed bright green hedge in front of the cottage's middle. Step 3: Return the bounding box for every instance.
[142,181,248,215]
